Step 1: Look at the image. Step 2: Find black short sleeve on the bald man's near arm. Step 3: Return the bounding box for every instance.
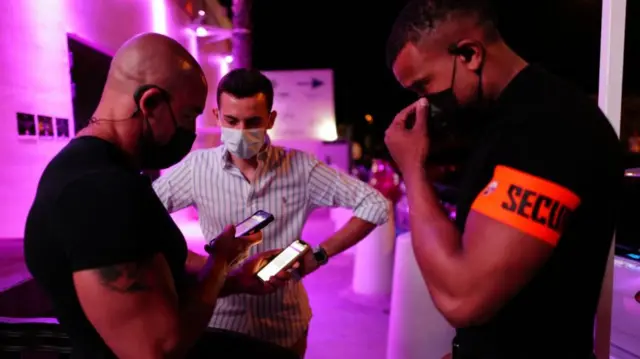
[56,173,164,271]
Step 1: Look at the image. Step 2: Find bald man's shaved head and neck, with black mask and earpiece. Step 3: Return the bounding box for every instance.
[85,33,208,169]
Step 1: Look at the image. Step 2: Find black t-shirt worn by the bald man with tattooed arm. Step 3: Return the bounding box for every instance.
[24,137,187,359]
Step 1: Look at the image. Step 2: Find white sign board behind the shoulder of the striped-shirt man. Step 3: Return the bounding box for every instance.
[263,70,338,141]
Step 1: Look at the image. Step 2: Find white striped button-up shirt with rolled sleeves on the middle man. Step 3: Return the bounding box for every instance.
[153,144,389,347]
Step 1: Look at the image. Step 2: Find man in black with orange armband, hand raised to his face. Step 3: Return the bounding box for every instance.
[385,0,623,359]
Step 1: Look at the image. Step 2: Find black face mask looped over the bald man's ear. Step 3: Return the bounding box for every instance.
[134,85,196,170]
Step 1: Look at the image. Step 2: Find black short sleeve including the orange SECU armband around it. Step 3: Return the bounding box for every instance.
[471,119,585,245]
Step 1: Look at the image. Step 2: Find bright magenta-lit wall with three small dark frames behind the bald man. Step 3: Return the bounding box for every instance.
[0,0,188,239]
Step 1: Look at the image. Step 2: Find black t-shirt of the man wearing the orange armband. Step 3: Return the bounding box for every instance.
[457,66,623,359]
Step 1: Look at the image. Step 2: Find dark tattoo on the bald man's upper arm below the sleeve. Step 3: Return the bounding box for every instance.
[98,261,150,293]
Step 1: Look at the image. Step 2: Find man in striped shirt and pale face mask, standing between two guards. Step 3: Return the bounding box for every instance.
[153,69,390,357]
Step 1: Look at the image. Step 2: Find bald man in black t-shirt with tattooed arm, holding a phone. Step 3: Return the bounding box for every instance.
[25,34,286,359]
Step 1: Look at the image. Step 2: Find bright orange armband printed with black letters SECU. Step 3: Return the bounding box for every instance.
[471,166,580,246]
